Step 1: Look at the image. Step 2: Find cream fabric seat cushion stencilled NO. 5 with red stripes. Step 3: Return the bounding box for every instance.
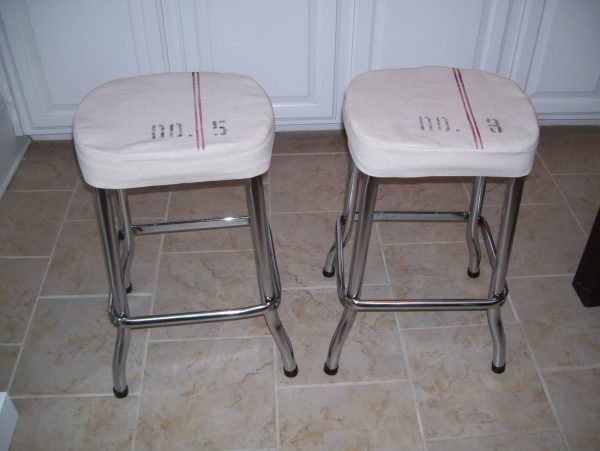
[73,72,274,189]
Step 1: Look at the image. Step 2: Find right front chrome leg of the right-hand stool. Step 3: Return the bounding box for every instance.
[487,177,525,373]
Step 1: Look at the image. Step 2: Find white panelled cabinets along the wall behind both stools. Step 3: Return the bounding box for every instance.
[0,0,600,135]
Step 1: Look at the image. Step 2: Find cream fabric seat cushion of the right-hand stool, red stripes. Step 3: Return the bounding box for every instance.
[344,67,539,177]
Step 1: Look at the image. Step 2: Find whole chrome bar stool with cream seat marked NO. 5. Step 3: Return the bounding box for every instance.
[73,72,298,398]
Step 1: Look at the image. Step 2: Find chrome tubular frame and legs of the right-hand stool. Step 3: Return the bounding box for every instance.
[323,159,525,375]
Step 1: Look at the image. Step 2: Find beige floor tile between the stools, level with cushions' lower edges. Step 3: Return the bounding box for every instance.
[270,154,348,213]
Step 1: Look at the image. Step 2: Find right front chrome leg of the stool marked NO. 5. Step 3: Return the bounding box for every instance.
[246,176,298,377]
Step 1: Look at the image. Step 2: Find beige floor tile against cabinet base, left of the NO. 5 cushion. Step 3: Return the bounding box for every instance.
[9,141,79,190]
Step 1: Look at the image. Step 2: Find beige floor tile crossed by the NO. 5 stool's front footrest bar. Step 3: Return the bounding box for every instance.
[152,251,269,338]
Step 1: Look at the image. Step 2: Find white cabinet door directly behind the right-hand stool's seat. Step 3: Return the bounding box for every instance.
[352,0,510,75]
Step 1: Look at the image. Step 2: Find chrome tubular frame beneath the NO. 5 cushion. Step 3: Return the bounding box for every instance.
[95,175,298,398]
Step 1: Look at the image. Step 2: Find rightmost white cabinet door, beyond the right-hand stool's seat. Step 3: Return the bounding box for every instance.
[507,0,600,124]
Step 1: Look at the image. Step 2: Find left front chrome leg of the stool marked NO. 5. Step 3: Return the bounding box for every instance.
[95,188,131,398]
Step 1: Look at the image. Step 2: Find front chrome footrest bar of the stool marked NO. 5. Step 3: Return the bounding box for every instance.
[109,300,277,329]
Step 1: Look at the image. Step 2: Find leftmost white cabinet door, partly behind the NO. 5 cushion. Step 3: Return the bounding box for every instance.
[0,0,166,135]
